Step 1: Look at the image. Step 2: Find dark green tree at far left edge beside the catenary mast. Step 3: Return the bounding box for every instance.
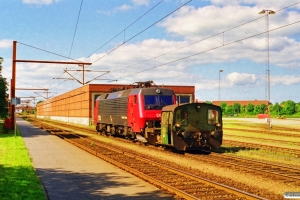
[0,57,8,119]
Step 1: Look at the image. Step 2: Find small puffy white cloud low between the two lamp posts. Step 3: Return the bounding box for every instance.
[226,72,257,86]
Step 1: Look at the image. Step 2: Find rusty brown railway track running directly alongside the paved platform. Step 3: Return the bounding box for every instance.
[44,129,263,200]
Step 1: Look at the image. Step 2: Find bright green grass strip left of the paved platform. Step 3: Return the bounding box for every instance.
[0,123,47,200]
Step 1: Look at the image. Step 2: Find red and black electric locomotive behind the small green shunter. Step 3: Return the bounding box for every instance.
[94,87,176,145]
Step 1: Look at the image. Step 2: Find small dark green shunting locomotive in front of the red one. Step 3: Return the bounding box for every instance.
[158,103,223,151]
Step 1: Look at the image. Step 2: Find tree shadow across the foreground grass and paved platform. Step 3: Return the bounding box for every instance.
[0,166,175,200]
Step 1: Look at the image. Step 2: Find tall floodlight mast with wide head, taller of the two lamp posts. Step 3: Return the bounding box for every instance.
[258,10,275,129]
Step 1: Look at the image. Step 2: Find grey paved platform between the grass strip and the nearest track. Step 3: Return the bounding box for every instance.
[16,118,174,200]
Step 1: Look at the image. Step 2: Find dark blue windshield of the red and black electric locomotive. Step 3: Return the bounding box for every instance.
[144,95,174,110]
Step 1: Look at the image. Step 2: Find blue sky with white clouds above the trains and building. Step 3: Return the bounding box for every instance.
[0,0,300,106]
